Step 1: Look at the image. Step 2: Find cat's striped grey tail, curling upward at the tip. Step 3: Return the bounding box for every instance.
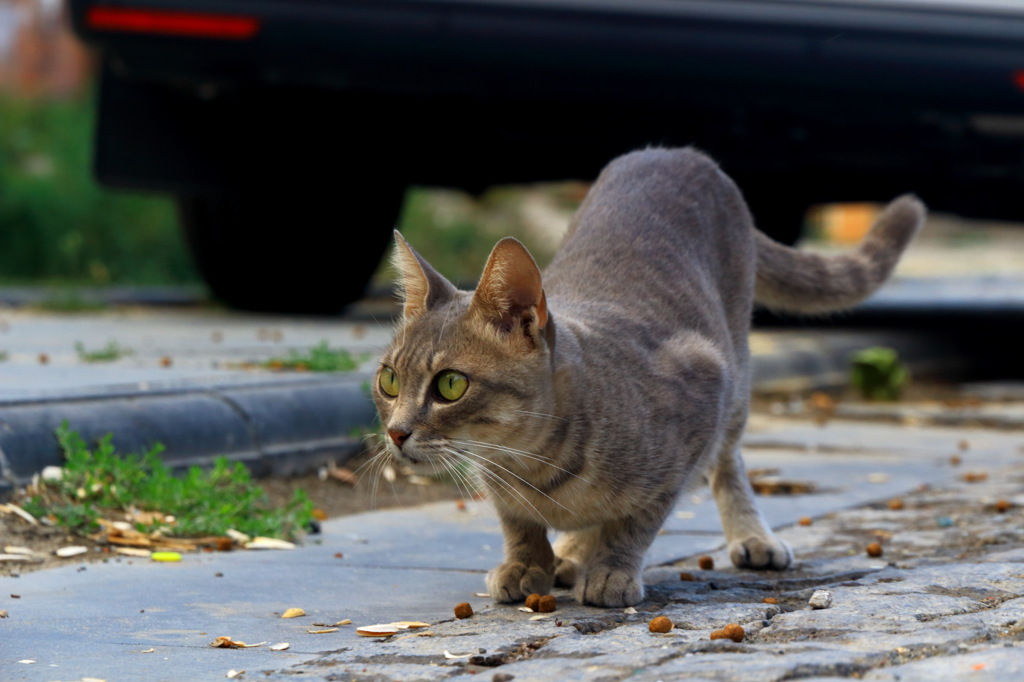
[755,195,926,314]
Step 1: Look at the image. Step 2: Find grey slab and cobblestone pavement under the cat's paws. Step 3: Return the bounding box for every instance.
[0,403,1024,682]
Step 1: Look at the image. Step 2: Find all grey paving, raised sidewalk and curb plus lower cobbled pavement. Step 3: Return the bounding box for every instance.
[0,288,1024,682]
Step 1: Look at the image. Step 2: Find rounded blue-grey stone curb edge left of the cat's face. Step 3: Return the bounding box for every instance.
[0,374,376,499]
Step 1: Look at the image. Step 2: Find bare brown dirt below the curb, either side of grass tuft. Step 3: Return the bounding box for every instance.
[0,448,462,576]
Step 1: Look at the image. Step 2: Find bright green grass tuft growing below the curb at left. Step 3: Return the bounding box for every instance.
[26,424,312,539]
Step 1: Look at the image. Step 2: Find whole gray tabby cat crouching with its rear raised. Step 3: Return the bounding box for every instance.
[374,148,925,606]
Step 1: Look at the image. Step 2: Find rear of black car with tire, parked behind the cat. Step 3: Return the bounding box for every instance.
[69,0,1024,312]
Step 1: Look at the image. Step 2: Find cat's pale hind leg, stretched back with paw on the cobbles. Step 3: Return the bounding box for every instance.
[708,416,793,570]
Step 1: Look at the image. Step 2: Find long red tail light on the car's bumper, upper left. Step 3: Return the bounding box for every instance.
[85,6,259,40]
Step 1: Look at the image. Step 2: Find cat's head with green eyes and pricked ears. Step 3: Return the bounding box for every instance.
[373,232,553,473]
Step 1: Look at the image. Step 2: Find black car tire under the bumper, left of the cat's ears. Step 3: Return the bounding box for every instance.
[177,186,404,314]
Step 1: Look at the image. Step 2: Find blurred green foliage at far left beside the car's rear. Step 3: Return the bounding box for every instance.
[0,93,198,284]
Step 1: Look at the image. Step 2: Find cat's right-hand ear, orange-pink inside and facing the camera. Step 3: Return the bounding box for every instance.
[472,237,548,337]
